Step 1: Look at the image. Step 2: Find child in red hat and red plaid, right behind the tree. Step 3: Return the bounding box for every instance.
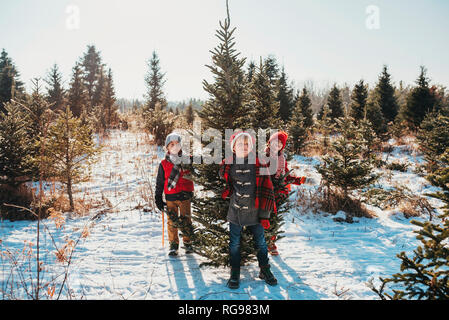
[265,131,306,256]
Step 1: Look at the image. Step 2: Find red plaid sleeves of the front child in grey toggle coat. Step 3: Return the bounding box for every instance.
[219,157,277,213]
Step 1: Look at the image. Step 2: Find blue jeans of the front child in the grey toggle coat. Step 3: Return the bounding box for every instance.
[229,222,268,269]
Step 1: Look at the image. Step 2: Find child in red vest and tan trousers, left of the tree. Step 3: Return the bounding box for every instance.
[155,133,193,256]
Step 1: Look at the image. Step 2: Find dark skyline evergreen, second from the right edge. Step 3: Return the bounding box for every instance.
[373,66,399,123]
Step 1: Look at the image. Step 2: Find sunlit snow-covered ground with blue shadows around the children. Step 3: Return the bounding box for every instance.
[0,131,437,300]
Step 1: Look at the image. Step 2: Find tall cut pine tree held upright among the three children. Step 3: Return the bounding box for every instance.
[186,3,255,266]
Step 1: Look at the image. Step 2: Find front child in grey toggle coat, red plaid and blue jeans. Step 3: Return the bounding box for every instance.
[219,131,277,289]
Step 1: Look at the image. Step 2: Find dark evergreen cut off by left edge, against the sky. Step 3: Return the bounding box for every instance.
[0,49,25,112]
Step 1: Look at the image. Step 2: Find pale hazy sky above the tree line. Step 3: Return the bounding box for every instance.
[0,0,449,101]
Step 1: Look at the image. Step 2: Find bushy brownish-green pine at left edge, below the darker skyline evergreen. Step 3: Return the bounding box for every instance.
[0,101,32,188]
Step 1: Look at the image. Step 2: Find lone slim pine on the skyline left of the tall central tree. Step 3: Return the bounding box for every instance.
[144,51,167,111]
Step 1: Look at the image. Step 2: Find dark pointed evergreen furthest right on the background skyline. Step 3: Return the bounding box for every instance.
[400,66,437,130]
